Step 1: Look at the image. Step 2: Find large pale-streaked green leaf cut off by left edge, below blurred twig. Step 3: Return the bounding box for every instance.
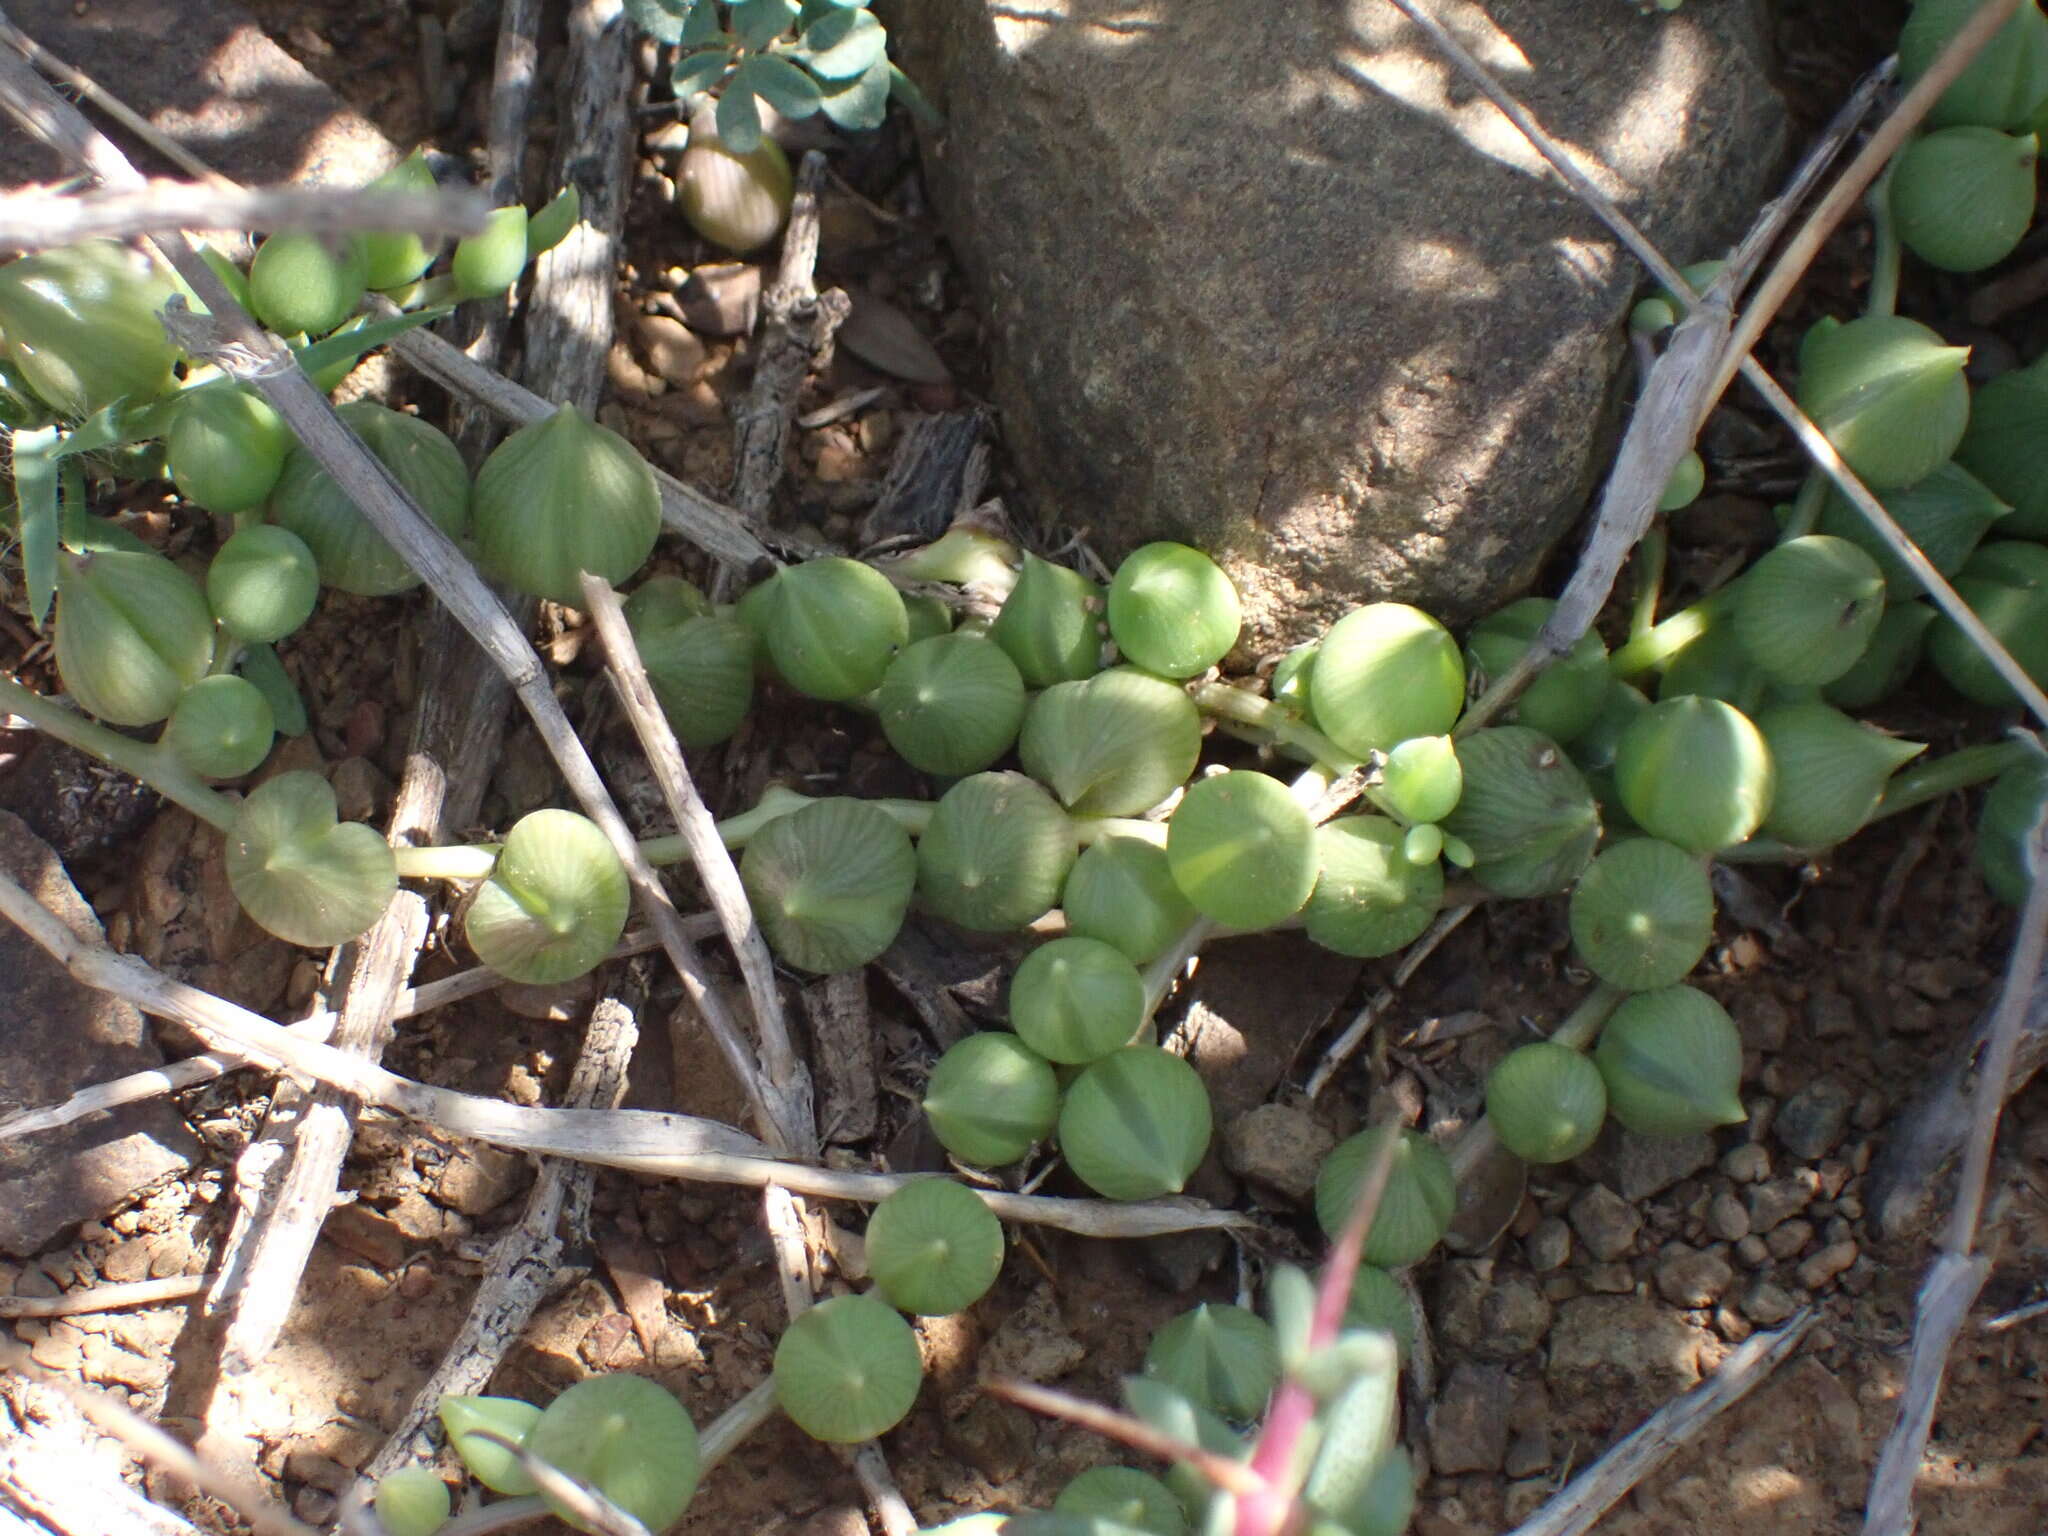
[0,240,178,418]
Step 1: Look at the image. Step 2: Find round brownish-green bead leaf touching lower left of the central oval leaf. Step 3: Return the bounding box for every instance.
[918,772,1075,934]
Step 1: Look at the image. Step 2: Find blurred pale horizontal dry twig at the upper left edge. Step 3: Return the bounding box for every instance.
[0,182,489,250]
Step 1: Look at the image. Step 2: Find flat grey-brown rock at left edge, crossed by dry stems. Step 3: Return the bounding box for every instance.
[0,811,199,1253]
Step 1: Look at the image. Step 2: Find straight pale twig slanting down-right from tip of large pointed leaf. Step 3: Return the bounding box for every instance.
[584,571,817,1157]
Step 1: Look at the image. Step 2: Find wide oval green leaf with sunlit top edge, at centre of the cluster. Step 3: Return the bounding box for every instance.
[1018,668,1202,815]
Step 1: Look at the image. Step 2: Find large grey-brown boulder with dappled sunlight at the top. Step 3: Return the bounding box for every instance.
[893,0,1786,647]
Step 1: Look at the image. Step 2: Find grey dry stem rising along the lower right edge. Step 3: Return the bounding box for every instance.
[1864,809,2048,1536]
